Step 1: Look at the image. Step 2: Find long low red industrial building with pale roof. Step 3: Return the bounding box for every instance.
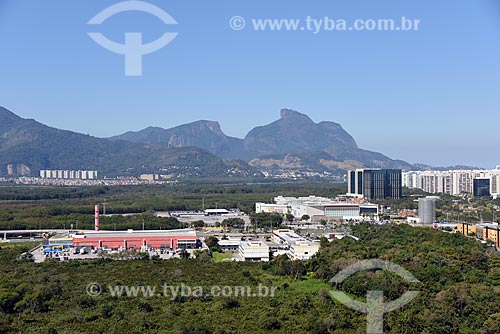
[73,229,197,249]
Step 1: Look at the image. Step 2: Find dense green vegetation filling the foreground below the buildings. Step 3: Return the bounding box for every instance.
[0,225,500,334]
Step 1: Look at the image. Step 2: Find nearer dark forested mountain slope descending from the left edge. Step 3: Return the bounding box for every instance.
[0,107,262,177]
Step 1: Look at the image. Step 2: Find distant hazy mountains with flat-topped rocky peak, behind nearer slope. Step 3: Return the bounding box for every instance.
[110,109,413,173]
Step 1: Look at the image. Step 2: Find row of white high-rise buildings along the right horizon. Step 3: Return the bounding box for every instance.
[402,166,500,197]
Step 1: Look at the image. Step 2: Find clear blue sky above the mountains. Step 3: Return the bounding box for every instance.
[0,0,500,167]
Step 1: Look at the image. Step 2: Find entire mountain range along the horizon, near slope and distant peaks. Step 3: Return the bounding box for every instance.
[0,107,413,177]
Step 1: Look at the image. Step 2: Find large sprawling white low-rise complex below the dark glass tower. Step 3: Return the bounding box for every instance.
[255,196,378,222]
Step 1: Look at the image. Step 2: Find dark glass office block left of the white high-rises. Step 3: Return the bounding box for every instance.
[347,169,402,200]
